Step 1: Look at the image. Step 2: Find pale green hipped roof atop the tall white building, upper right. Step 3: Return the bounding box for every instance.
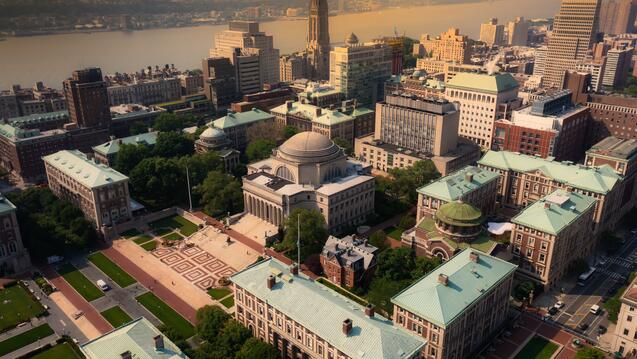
[447,72,520,94]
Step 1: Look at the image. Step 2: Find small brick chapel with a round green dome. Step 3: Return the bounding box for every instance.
[402,200,496,260]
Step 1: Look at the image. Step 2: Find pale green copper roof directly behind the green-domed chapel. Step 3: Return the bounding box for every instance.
[418,166,499,202]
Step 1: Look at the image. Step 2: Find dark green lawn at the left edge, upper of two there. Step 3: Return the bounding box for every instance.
[0,284,46,331]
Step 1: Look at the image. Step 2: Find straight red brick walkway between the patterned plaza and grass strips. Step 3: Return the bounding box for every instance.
[102,248,197,324]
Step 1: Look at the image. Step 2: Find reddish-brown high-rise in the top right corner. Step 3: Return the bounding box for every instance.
[599,0,637,35]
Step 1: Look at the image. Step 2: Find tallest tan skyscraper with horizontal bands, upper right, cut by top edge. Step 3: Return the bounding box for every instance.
[543,0,600,88]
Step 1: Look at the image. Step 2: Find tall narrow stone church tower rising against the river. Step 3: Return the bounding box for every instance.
[306,0,330,80]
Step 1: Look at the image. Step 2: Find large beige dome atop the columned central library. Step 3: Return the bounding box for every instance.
[277,131,343,163]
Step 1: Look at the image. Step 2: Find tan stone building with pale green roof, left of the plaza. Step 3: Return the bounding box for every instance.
[42,150,131,229]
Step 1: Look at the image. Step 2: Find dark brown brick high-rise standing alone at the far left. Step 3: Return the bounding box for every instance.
[64,68,111,128]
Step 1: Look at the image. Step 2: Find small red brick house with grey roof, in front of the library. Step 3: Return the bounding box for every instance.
[320,235,380,288]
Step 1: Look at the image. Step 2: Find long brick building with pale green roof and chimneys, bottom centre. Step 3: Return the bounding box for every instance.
[230,259,426,359]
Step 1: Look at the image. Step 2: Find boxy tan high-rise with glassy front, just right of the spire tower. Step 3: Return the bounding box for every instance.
[330,34,392,104]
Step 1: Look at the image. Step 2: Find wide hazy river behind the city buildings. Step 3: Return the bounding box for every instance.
[0,0,560,89]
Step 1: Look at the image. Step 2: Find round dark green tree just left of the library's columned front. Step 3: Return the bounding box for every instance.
[195,171,243,216]
